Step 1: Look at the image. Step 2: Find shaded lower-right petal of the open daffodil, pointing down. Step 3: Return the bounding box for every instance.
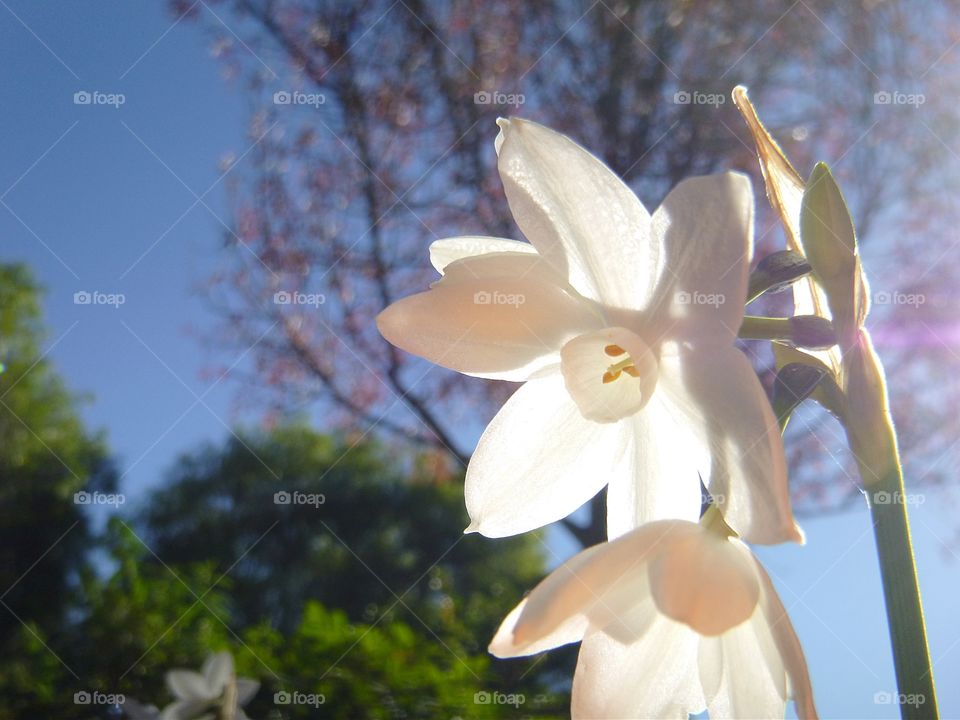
[657,346,803,544]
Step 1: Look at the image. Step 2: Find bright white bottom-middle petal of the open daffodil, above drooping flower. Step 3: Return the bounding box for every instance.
[607,392,709,540]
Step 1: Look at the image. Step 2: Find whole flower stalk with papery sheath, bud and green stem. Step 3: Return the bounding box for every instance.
[733,87,938,719]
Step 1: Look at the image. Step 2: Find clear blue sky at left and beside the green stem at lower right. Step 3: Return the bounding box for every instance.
[0,0,960,718]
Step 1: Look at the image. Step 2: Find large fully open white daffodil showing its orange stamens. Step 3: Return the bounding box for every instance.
[377,120,801,543]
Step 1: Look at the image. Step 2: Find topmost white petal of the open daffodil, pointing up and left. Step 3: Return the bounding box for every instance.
[497,119,660,310]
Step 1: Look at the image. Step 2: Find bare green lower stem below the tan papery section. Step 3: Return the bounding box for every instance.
[868,464,939,720]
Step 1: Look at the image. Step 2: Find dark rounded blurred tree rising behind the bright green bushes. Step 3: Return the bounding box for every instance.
[142,427,544,652]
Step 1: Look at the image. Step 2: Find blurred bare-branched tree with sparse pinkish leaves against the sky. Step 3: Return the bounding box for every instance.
[171,0,956,544]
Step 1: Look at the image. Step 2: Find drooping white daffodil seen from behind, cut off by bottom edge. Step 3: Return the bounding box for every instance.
[490,510,816,720]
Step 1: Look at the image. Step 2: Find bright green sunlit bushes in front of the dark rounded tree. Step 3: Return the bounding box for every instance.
[62,520,567,720]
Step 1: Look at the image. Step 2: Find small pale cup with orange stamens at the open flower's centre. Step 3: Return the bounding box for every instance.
[560,327,659,422]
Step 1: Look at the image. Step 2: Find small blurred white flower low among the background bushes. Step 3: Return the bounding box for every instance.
[160,651,260,720]
